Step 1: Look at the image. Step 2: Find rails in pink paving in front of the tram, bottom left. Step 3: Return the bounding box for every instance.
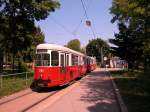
[0,90,61,112]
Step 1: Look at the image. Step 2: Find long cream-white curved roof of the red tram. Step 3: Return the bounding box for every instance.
[36,43,84,56]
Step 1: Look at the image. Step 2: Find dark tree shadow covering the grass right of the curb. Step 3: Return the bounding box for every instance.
[115,77,150,112]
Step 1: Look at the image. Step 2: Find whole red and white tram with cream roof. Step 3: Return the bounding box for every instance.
[33,44,96,87]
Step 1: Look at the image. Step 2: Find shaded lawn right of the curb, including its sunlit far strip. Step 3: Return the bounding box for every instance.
[111,71,150,112]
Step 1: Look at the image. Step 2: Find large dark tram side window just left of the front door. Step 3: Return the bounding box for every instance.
[51,51,59,66]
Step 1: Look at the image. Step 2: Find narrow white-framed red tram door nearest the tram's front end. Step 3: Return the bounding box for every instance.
[60,53,66,81]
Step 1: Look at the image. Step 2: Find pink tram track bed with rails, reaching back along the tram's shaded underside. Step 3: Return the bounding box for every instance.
[0,80,82,112]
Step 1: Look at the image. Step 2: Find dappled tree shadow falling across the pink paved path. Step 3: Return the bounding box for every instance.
[80,71,119,112]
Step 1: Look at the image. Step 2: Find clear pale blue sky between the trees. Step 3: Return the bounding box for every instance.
[36,0,118,47]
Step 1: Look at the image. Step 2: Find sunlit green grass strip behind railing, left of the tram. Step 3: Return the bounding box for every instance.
[0,73,33,97]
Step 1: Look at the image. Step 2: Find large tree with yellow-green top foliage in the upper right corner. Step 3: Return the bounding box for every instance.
[110,0,150,68]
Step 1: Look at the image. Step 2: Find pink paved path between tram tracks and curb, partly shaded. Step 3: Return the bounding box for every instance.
[34,69,119,112]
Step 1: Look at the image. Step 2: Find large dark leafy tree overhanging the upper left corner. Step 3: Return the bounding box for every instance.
[0,0,60,71]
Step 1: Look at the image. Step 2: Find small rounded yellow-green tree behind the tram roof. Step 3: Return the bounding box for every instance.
[66,39,81,52]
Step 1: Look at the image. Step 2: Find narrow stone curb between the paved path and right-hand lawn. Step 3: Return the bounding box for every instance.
[107,71,128,112]
